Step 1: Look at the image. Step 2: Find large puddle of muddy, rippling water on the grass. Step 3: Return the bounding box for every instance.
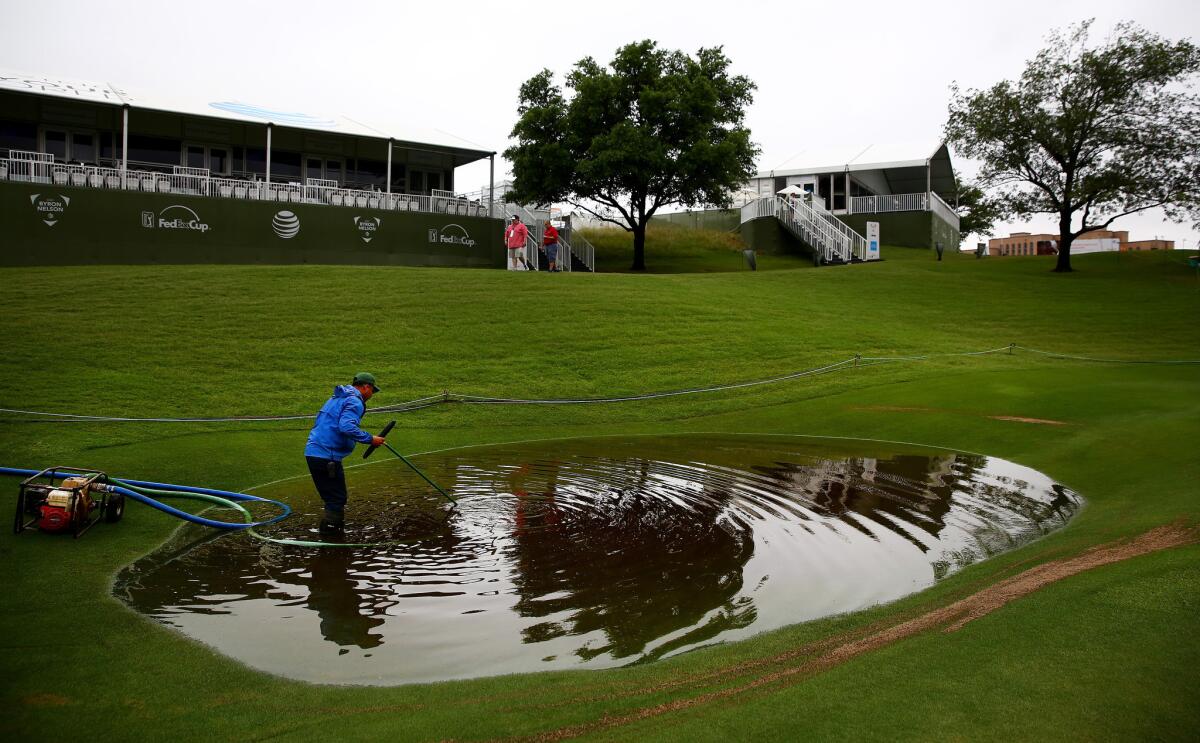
[114,435,1081,684]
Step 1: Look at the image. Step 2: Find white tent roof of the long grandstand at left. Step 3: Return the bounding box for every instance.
[0,70,491,156]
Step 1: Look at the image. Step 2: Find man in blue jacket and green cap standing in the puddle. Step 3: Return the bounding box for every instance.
[304,372,384,537]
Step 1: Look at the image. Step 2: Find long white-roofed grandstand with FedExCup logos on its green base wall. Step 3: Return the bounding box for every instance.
[0,73,505,268]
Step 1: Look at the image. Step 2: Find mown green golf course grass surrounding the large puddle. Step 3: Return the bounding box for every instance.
[0,245,1200,741]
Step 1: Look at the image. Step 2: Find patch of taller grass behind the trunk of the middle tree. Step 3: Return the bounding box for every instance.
[581,223,809,274]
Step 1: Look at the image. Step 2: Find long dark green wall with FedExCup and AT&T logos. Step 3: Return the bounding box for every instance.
[0,182,505,268]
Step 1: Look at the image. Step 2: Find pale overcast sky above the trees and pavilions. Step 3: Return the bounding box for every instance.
[0,0,1200,247]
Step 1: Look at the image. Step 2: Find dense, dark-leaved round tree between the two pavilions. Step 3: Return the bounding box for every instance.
[504,41,758,270]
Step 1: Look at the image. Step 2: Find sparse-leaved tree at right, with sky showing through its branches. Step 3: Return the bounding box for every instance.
[946,20,1200,271]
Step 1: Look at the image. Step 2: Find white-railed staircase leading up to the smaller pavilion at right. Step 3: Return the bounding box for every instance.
[742,194,866,265]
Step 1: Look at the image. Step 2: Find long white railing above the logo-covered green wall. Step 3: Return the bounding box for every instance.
[0,150,492,220]
